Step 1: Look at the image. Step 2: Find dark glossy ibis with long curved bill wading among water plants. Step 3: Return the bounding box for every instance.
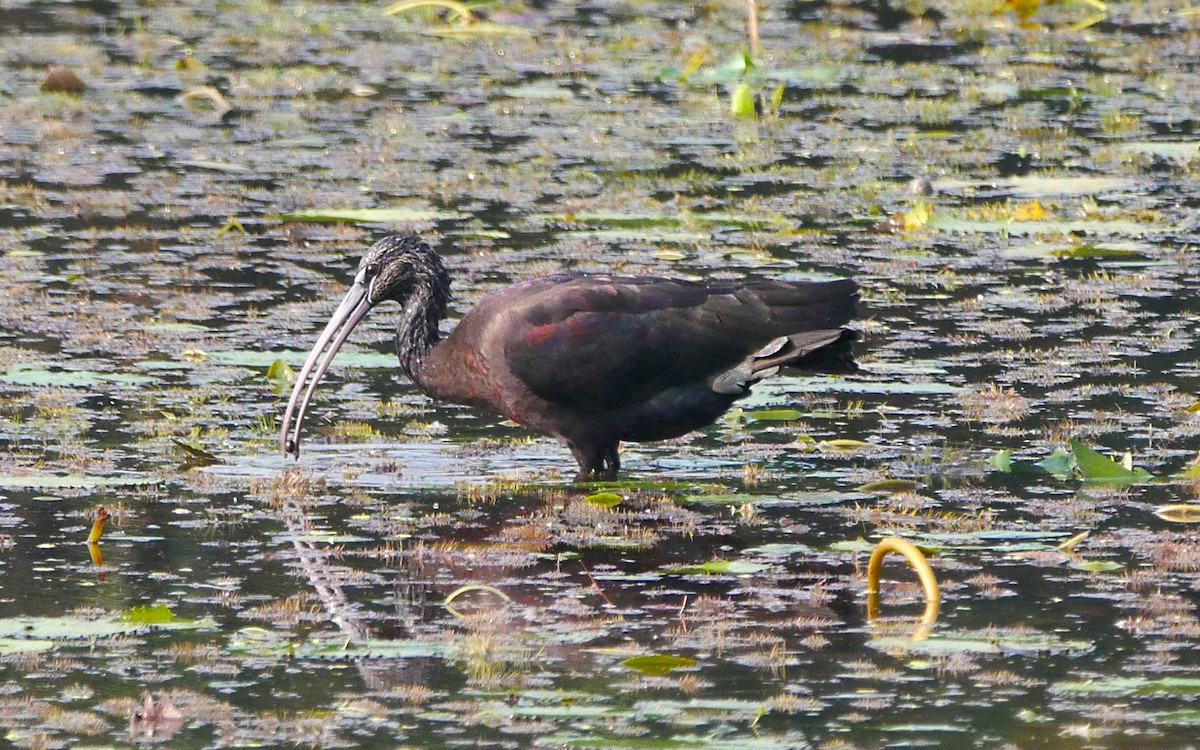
[280,234,859,481]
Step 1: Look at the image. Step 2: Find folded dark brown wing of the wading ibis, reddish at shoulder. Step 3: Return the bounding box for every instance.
[493,276,858,412]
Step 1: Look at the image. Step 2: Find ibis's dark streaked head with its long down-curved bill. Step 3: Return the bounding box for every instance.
[280,234,450,456]
